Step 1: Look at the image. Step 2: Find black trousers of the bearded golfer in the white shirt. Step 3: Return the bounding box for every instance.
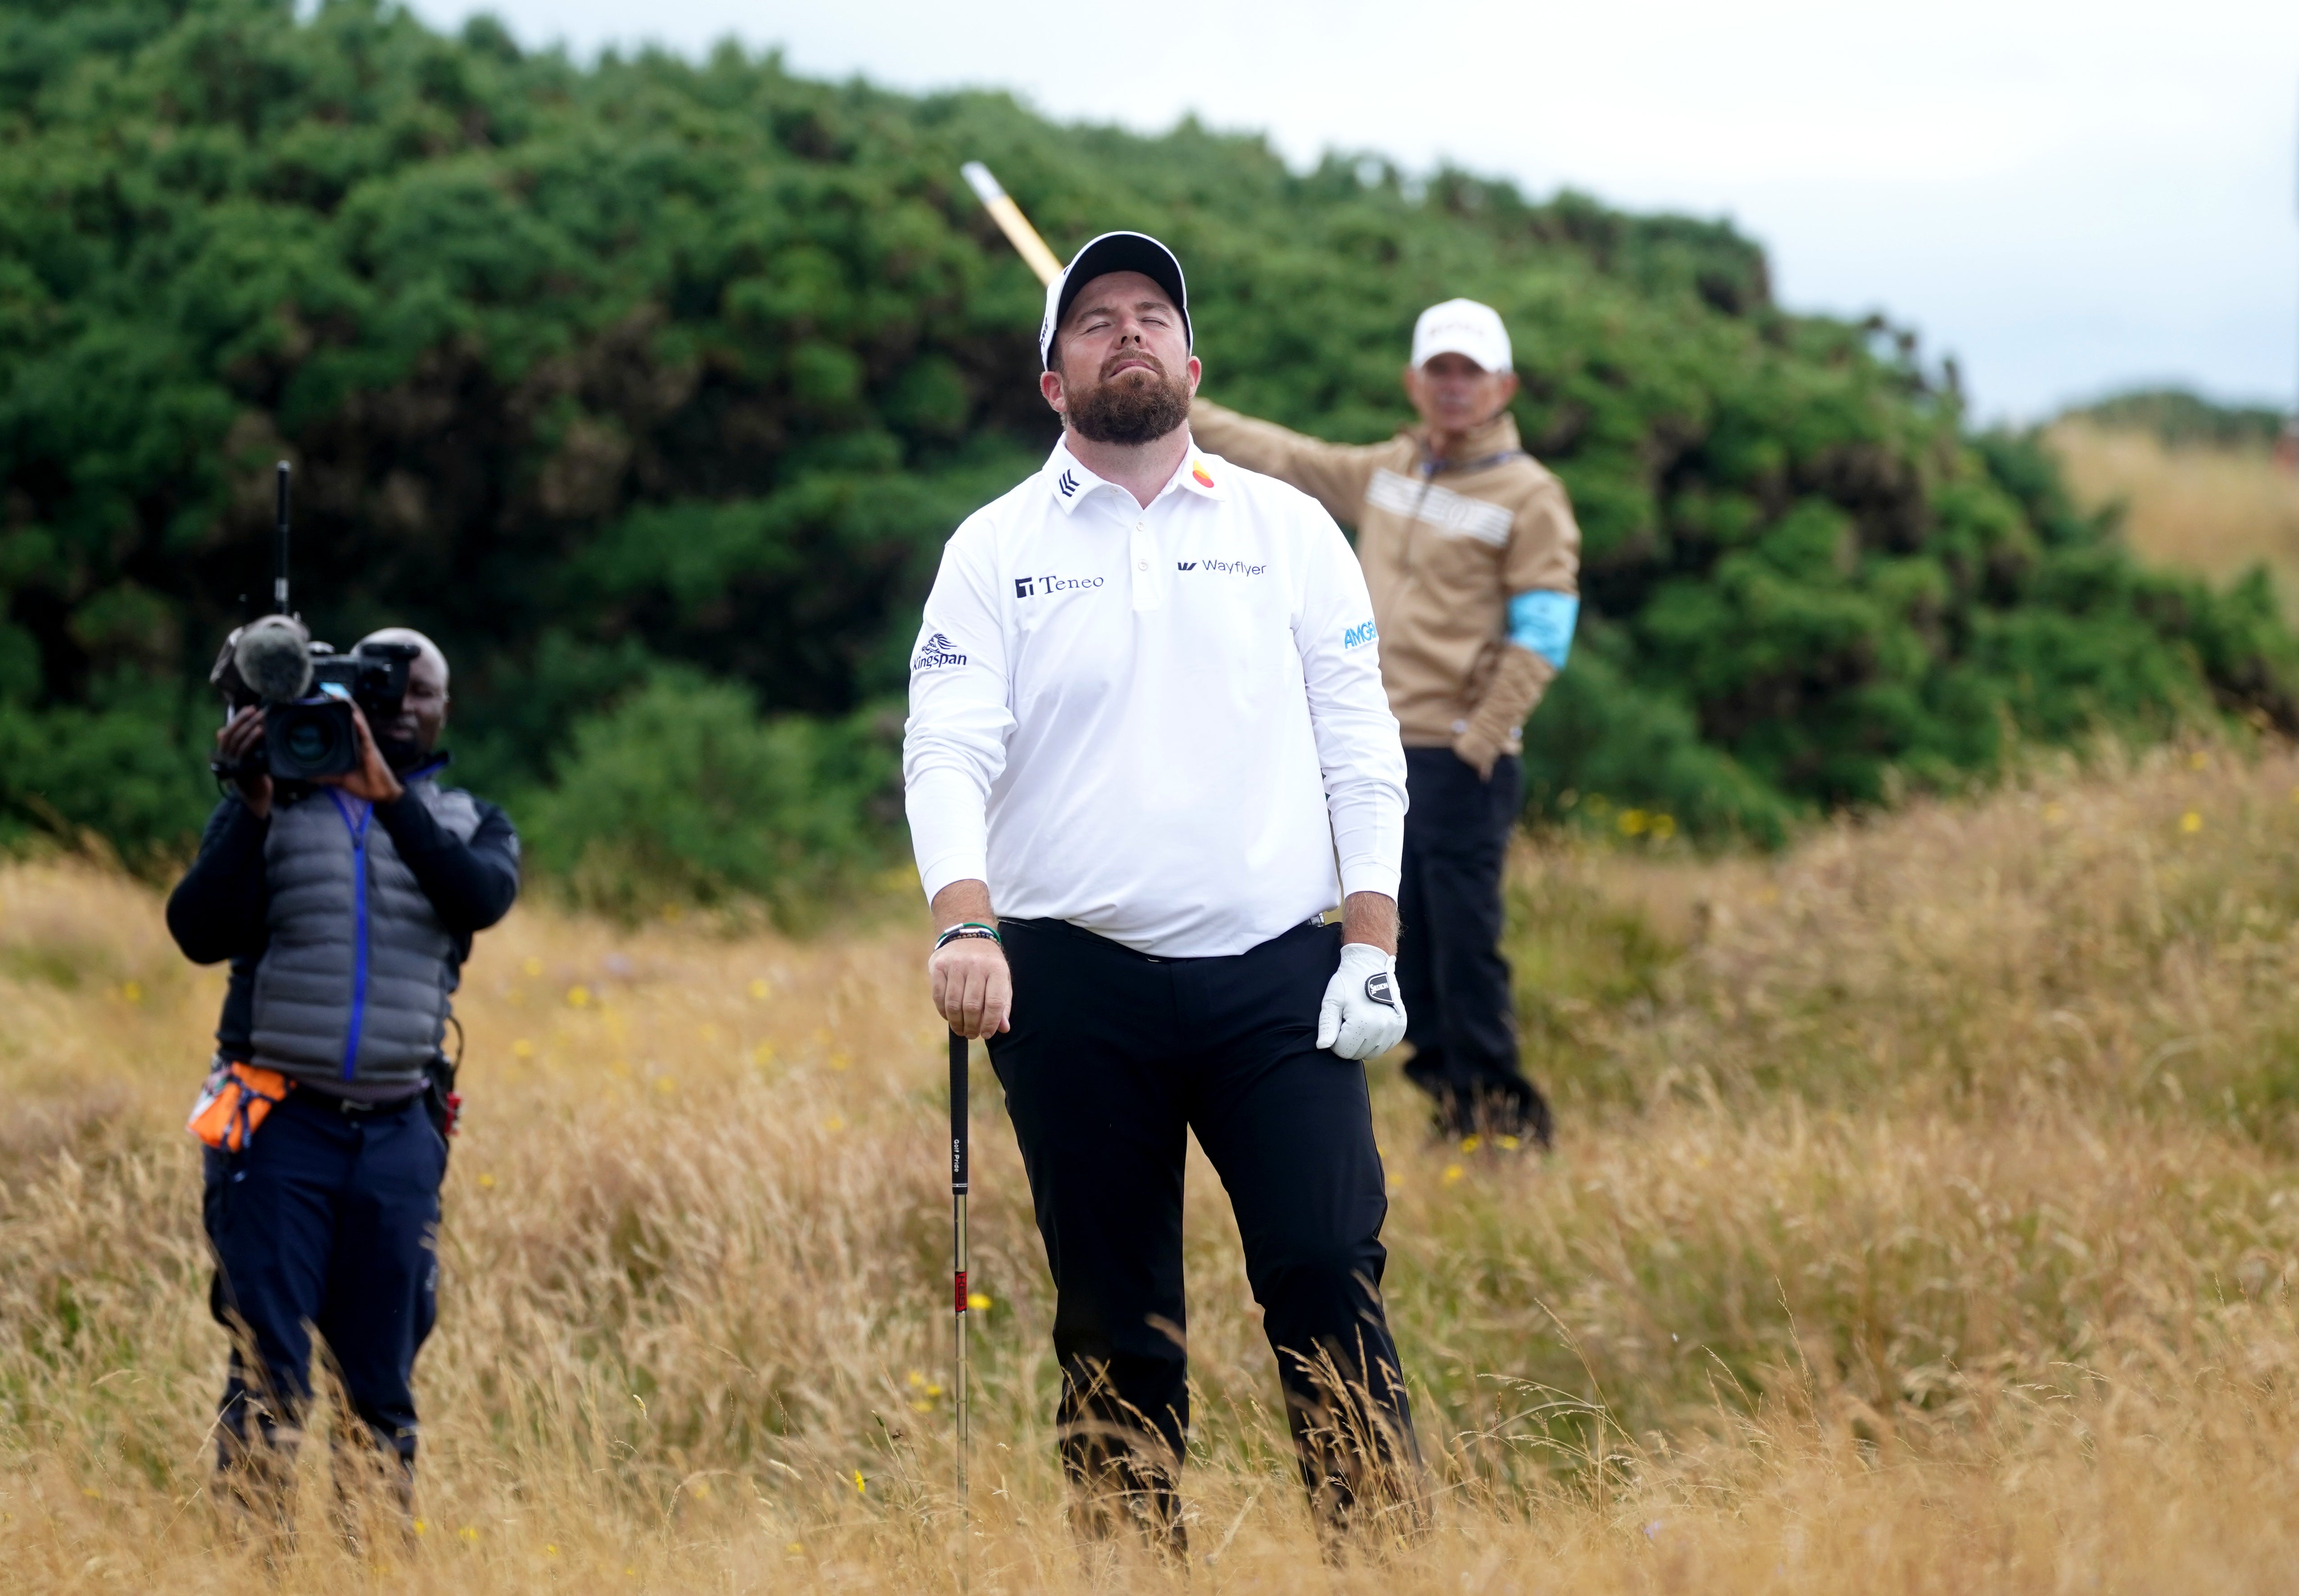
[989,920,1421,1541]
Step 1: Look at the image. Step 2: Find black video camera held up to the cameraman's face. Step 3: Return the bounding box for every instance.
[209,614,418,782]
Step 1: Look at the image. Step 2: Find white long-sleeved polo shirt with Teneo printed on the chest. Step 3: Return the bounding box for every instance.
[901,444,1405,959]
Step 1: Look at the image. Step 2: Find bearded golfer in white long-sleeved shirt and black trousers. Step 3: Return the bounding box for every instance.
[904,232,1418,1546]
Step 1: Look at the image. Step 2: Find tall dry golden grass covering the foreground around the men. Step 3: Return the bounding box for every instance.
[0,750,2299,1596]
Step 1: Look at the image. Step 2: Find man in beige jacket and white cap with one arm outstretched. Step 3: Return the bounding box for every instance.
[1189,299,1579,1145]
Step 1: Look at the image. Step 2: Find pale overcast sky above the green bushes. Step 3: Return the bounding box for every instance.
[414,0,2299,419]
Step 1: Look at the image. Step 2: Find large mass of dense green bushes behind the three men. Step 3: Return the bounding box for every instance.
[0,0,2299,892]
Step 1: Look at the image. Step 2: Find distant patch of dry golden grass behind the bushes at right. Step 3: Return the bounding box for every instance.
[2046,421,2299,621]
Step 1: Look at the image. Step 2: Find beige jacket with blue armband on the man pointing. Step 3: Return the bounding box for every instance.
[1189,398,1579,764]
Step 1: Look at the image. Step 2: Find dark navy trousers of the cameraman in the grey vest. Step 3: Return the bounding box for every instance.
[204,1085,446,1506]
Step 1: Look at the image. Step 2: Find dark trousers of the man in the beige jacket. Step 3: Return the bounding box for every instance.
[1398,747,1554,1145]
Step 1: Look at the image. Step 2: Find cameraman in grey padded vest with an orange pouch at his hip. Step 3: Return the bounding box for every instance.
[168,628,520,1529]
